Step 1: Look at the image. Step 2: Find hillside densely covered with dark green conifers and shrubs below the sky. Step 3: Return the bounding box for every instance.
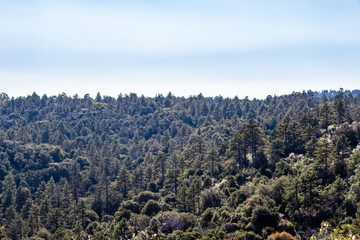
[0,89,360,240]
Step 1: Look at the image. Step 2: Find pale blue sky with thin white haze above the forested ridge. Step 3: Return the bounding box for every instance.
[0,0,360,98]
